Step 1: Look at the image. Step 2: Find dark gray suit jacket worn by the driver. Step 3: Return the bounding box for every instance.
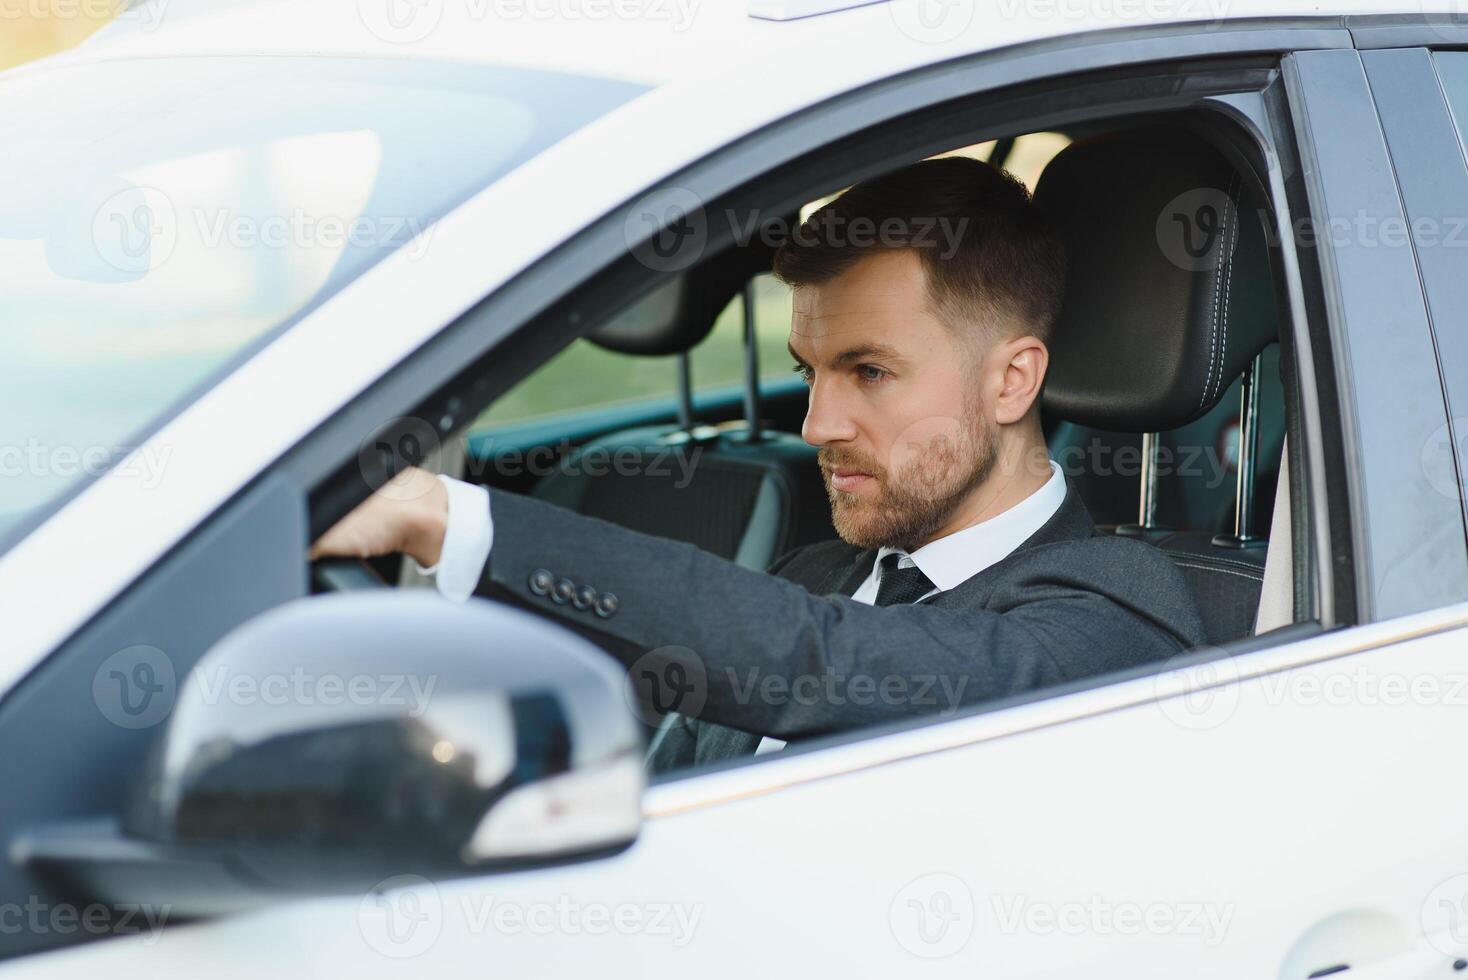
[479,487,1204,767]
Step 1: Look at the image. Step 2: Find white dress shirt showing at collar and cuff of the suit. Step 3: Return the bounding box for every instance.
[422,461,1066,756]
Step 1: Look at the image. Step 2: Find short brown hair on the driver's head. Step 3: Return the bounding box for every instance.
[774,157,1066,340]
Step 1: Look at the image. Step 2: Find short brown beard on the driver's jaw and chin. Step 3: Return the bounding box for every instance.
[818,408,998,552]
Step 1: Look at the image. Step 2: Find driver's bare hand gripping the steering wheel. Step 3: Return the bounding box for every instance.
[311,467,449,568]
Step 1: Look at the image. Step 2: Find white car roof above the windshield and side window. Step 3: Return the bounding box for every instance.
[20,0,1455,92]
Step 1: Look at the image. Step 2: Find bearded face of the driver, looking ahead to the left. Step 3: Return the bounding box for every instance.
[790,249,997,550]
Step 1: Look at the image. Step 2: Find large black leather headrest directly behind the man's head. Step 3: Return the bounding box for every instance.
[1035,128,1279,433]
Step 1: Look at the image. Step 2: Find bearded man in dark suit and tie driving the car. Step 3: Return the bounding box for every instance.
[313,158,1202,769]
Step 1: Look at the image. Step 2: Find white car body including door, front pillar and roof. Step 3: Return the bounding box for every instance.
[0,0,1468,980]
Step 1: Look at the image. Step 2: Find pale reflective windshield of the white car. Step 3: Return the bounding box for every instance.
[0,57,642,553]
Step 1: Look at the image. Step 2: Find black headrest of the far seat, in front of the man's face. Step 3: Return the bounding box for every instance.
[587,239,775,356]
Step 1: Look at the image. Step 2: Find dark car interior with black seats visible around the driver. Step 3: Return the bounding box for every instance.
[330,117,1299,774]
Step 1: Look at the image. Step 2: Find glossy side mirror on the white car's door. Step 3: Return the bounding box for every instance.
[18,591,644,915]
